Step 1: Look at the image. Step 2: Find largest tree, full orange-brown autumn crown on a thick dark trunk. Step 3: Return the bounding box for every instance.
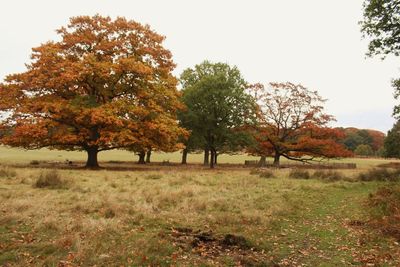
[0,15,184,167]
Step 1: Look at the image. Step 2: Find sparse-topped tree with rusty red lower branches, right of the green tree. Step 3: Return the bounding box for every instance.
[252,82,351,165]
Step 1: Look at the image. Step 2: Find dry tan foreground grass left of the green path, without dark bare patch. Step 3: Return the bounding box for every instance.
[0,163,398,266]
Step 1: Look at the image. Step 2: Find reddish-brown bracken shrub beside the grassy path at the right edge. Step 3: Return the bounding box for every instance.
[367,184,400,240]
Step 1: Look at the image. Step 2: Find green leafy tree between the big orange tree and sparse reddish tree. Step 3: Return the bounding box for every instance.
[179,61,256,168]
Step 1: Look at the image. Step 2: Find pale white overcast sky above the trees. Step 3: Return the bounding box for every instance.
[0,0,400,131]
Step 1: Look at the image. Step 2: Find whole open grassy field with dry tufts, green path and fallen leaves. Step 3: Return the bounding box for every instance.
[0,148,400,266]
